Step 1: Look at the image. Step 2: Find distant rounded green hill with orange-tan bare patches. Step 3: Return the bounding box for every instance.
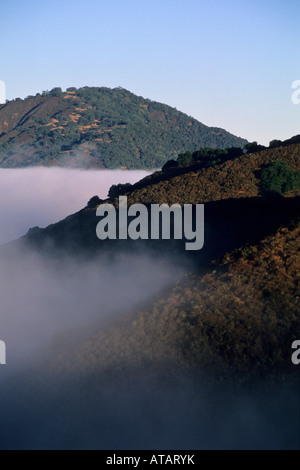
[0,87,247,169]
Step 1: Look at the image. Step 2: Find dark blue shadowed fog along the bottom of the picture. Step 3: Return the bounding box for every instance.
[0,370,299,450]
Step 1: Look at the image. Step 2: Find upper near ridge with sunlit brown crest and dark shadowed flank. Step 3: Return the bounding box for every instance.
[6,144,300,256]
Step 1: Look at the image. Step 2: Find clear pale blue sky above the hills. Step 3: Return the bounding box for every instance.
[0,0,300,144]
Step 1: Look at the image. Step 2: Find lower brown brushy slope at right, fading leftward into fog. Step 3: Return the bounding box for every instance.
[47,218,300,384]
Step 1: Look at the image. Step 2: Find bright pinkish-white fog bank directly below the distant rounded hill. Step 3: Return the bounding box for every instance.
[0,167,150,245]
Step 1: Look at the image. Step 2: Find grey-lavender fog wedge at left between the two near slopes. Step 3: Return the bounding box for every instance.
[0,244,186,370]
